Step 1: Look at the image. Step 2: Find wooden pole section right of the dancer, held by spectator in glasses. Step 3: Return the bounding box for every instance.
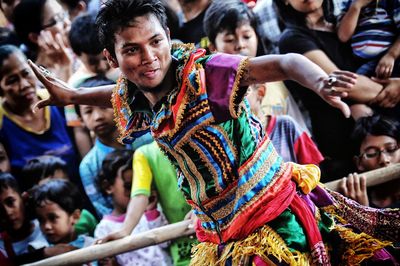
[325,163,400,191]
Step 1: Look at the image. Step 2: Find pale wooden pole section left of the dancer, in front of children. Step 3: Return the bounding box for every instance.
[26,220,194,266]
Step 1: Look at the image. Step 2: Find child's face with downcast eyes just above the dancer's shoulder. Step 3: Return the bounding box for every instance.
[211,23,258,56]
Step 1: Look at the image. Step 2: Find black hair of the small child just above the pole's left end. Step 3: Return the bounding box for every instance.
[33,179,82,214]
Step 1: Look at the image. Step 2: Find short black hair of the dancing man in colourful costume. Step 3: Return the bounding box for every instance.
[96,0,167,58]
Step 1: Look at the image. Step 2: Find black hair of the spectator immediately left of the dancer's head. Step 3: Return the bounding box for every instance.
[68,13,103,56]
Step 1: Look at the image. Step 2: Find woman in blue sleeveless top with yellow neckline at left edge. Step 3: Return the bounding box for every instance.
[0,45,78,191]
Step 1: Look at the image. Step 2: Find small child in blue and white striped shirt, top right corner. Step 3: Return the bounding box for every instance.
[337,0,400,79]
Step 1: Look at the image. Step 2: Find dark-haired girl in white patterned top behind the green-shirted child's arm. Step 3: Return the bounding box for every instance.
[95,150,171,265]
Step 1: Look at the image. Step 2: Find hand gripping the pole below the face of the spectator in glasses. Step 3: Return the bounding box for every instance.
[339,173,369,206]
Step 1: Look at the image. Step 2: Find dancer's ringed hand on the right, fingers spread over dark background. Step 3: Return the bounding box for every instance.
[317,70,357,117]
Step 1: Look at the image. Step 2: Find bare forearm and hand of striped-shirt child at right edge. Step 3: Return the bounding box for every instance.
[375,37,400,79]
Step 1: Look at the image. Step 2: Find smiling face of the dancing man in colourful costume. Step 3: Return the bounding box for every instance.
[107,15,171,92]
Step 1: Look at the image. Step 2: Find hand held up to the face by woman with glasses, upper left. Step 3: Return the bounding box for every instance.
[36,31,73,81]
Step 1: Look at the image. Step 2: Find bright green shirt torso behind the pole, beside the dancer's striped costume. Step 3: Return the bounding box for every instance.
[139,142,197,266]
